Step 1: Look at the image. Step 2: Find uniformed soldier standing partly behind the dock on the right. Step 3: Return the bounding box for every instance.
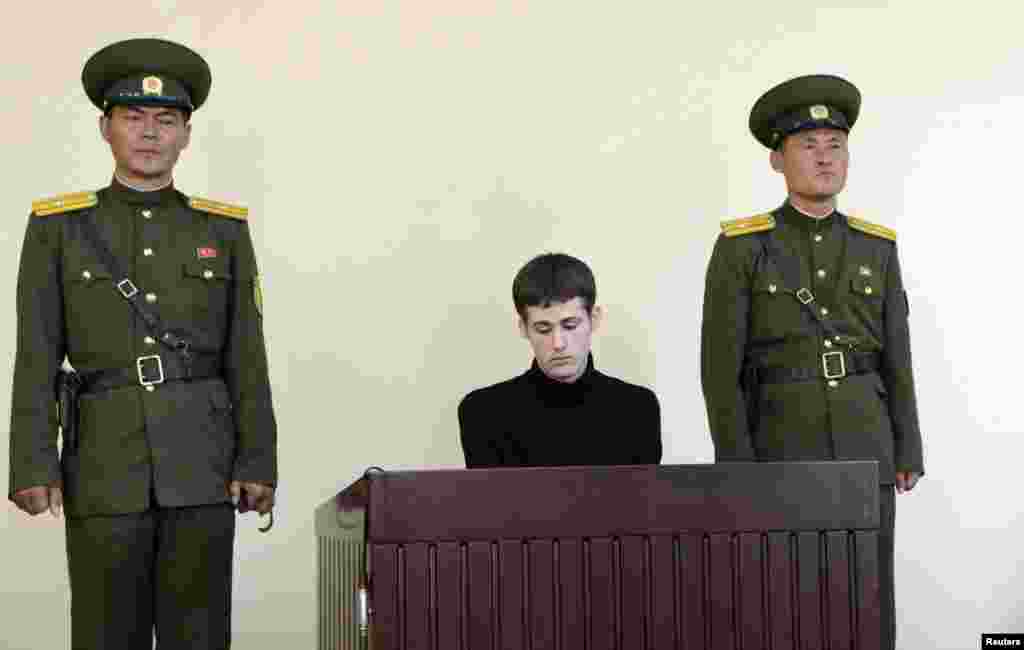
[700,75,925,648]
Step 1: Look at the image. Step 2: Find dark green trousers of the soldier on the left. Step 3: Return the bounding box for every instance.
[66,504,234,650]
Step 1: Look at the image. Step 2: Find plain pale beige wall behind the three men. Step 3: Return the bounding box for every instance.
[0,0,1024,650]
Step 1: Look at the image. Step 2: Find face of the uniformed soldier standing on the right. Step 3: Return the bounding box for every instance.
[771,129,850,201]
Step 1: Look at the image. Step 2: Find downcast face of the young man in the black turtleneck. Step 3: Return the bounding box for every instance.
[518,298,601,384]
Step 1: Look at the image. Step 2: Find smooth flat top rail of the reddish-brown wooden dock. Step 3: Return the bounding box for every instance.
[335,461,880,544]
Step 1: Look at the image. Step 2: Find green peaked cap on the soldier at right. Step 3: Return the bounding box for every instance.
[751,75,860,149]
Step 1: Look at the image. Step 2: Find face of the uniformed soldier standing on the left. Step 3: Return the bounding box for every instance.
[99,106,191,182]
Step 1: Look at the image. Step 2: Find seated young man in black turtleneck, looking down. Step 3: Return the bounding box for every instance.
[459,253,662,469]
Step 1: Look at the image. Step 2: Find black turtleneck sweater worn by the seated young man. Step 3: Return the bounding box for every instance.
[459,355,662,469]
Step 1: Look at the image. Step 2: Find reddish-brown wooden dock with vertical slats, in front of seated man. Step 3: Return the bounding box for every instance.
[316,462,881,650]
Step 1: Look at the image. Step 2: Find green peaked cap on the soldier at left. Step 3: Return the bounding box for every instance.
[82,38,213,113]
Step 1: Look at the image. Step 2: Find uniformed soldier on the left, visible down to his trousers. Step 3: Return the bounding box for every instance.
[8,39,278,650]
